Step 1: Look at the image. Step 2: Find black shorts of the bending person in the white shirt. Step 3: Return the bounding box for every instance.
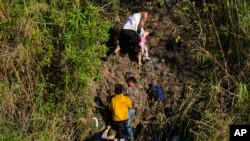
[119,29,140,54]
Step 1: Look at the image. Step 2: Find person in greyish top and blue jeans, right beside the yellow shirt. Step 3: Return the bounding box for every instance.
[126,77,141,141]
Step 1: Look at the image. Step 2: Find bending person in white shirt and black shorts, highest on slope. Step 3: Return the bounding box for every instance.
[114,10,148,65]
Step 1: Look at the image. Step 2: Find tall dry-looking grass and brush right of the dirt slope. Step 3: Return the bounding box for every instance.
[174,0,250,140]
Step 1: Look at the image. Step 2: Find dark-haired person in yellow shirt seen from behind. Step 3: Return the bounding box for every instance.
[109,84,132,139]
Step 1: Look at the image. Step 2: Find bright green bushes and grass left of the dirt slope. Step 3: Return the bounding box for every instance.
[0,0,111,141]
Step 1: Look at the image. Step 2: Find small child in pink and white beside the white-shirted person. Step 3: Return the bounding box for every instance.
[138,28,150,65]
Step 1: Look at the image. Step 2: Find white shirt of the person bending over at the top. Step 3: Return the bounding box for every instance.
[122,13,141,32]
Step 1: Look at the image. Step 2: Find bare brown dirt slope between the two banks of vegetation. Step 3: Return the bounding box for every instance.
[96,4,197,140]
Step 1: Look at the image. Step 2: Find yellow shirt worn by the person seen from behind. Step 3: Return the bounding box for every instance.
[109,94,132,121]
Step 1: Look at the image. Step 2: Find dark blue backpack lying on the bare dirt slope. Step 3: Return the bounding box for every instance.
[147,82,165,101]
